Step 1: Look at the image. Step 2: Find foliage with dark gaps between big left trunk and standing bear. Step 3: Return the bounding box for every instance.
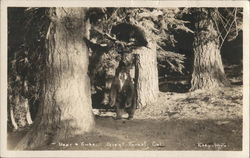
[83,38,121,106]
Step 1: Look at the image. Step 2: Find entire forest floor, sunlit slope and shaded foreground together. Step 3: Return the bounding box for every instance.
[8,63,243,150]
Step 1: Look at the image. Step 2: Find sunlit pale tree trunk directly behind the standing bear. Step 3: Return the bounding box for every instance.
[134,41,159,109]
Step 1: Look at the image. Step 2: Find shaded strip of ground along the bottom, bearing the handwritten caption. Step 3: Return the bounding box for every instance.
[8,117,242,151]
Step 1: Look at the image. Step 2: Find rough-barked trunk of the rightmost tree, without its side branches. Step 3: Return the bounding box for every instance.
[190,9,229,91]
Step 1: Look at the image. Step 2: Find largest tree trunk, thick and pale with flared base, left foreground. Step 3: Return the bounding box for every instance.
[16,8,94,149]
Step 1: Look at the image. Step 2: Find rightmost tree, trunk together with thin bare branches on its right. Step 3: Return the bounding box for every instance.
[190,8,242,90]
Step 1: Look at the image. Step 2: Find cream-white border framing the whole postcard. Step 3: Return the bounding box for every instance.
[0,0,250,158]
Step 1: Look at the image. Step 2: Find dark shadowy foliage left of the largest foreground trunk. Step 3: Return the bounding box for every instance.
[8,7,50,127]
